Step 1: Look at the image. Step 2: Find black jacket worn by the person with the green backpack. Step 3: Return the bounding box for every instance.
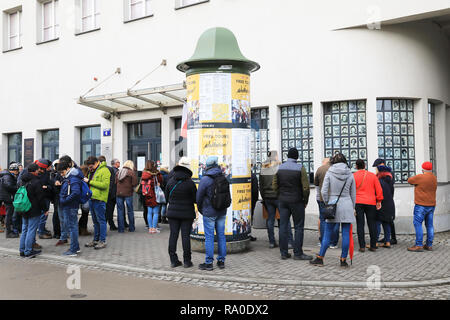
[22,172,48,218]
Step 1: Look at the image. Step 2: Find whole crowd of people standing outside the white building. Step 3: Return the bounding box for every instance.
[0,148,437,270]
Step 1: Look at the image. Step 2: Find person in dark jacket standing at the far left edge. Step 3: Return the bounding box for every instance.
[0,163,19,238]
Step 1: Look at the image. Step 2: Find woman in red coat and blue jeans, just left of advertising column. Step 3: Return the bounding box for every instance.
[141,160,163,233]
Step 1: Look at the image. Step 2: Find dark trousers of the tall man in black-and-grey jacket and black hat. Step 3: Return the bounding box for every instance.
[279,201,305,256]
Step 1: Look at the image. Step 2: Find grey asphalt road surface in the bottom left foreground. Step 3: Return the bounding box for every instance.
[0,257,268,300]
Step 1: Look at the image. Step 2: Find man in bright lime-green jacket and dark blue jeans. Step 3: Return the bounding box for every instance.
[84,156,111,249]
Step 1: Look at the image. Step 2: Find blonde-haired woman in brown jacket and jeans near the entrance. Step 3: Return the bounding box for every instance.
[116,160,138,233]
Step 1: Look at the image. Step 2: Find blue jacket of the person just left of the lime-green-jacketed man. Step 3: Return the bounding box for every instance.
[59,168,84,209]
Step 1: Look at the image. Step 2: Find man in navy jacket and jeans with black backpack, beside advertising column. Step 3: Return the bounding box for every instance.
[196,156,231,271]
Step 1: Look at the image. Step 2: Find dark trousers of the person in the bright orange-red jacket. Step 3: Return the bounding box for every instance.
[355,203,377,248]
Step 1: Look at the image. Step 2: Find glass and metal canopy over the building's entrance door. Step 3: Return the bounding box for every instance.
[77,82,186,115]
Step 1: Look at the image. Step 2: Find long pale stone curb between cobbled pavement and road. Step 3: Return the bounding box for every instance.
[0,247,450,290]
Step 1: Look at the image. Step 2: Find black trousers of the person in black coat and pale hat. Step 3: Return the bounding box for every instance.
[168,218,194,263]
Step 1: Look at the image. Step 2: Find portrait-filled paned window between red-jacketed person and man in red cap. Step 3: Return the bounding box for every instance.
[377,99,416,183]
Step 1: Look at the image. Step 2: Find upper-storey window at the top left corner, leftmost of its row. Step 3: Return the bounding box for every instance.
[3,7,22,51]
